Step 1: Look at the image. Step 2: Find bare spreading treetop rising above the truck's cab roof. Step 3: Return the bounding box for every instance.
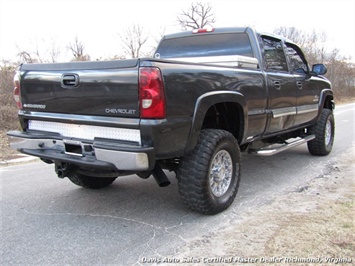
[177,2,216,30]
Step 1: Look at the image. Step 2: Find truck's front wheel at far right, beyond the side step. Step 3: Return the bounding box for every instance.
[307,109,335,156]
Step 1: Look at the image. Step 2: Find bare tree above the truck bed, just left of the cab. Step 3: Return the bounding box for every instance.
[118,24,149,58]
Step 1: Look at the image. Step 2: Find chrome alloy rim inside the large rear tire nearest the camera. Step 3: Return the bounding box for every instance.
[209,150,233,197]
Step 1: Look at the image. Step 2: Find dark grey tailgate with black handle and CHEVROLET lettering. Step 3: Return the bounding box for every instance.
[20,59,139,117]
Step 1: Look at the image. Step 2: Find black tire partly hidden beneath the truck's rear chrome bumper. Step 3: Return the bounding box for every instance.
[68,172,116,189]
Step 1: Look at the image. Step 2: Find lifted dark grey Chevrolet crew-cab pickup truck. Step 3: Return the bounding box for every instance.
[8,27,335,214]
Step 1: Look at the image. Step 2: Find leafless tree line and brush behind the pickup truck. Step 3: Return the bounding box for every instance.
[0,2,355,129]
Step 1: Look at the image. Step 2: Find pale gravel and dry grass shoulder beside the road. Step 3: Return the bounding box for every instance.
[168,147,355,265]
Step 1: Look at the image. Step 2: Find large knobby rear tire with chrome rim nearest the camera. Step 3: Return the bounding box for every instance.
[178,129,241,214]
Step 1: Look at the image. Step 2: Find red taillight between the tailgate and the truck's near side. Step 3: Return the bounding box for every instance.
[139,67,165,119]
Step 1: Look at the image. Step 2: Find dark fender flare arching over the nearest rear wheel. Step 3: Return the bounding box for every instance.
[185,91,248,153]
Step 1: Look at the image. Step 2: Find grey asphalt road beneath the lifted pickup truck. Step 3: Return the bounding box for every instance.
[0,104,355,265]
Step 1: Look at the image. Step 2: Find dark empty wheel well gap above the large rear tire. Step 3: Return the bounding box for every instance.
[202,102,244,143]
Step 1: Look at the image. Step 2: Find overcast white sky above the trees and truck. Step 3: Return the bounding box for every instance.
[0,0,355,61]
